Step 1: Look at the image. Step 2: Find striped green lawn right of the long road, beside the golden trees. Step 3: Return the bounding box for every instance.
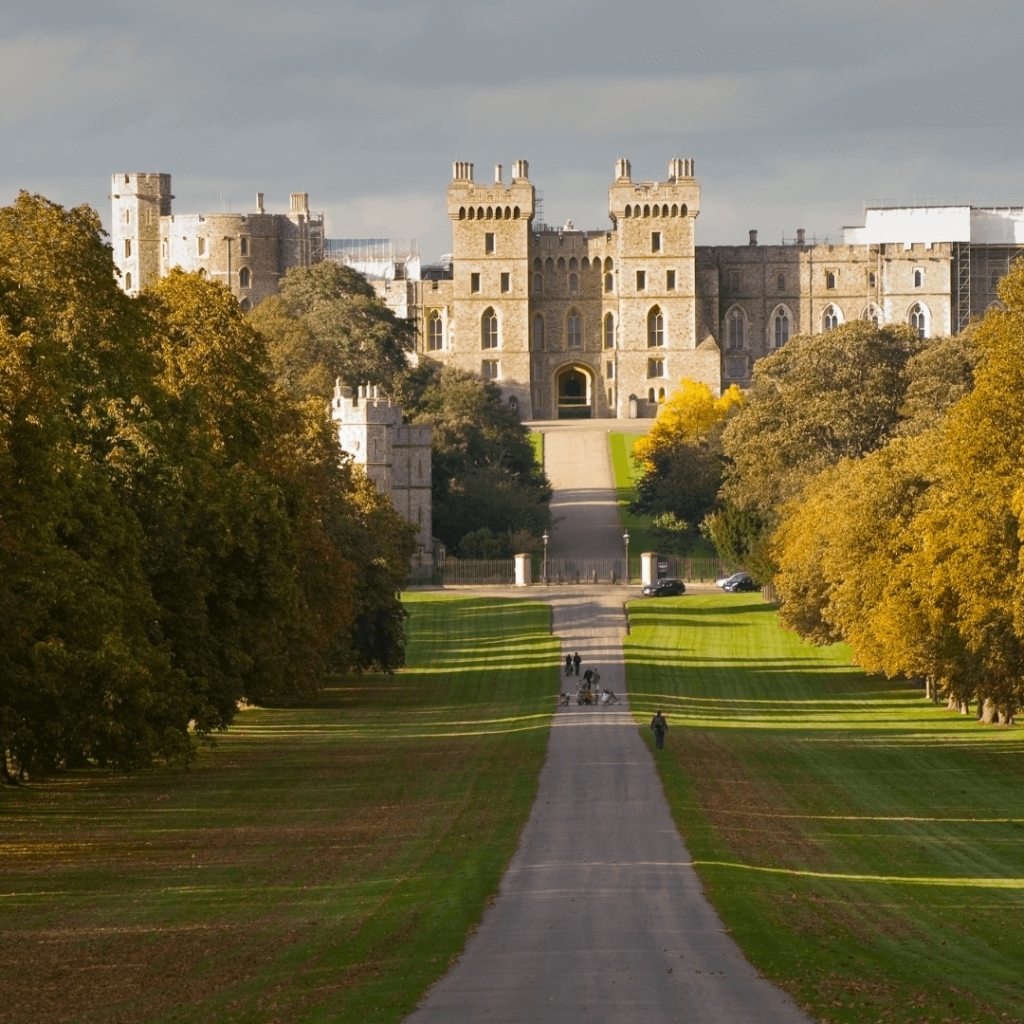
[626,595,1024,1024]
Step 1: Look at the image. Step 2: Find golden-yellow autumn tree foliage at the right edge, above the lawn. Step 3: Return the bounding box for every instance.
[773,264,1024,722]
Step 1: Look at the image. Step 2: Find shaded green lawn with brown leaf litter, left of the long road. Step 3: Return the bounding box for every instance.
[0,594,558,1024]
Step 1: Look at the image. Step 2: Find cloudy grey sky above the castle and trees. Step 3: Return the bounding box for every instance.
[0,0,1024,261]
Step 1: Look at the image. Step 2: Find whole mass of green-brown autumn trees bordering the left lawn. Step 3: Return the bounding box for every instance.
[0,194,413,777]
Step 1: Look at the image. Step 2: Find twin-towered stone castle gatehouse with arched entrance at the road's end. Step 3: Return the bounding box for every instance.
[407,160,721,419]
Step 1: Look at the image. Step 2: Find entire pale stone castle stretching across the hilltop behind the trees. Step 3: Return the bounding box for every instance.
[112,165,1024,420]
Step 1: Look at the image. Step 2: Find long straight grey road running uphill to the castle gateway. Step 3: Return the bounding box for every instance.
[407,421,810,1024]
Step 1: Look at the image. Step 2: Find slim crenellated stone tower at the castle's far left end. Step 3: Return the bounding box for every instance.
[111,172,174,295]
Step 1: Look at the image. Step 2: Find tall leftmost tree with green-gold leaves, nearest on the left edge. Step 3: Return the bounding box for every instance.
[0,193,189,777]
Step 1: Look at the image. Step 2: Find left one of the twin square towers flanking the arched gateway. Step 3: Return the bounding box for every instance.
[446,160,536,419]
